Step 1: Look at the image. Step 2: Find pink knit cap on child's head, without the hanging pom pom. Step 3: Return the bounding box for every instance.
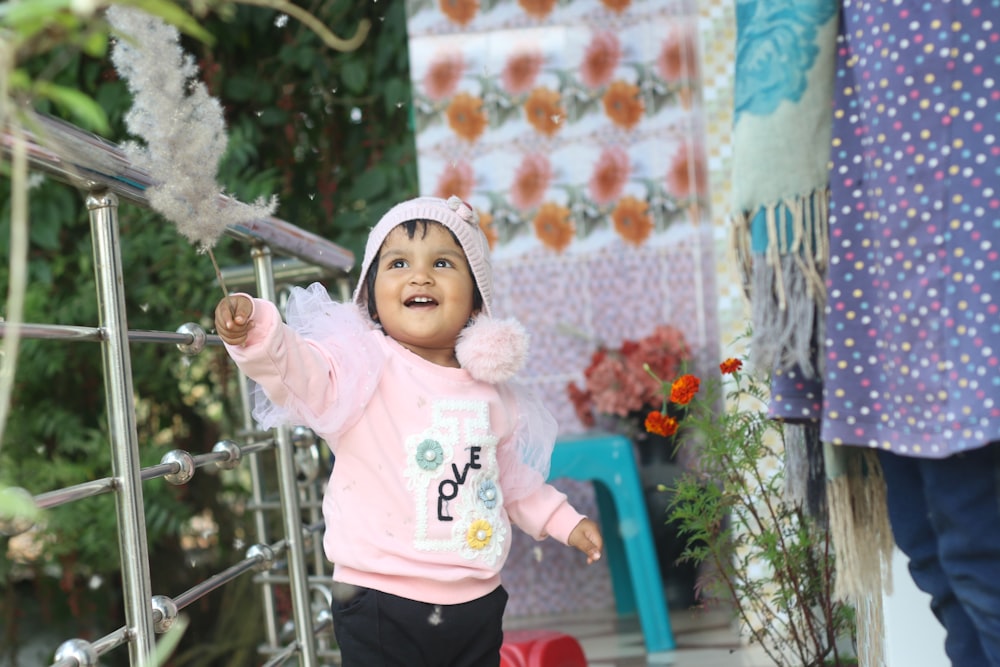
[354,196,493,315]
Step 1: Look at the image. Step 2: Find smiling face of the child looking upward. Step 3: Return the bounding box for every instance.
[375,223,475,367]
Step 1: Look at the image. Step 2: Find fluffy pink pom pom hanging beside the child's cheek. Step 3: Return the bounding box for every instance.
[455,315,528,384]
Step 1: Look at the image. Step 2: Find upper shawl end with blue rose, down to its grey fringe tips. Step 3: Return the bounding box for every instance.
[732,0,837,376]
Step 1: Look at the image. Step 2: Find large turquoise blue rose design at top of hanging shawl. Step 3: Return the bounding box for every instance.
[733,0,838,120]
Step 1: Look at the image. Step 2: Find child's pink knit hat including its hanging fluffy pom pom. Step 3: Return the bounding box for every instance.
[354,196,528,384]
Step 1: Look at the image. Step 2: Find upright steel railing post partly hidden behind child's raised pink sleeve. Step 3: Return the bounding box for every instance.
[251,246,319,667]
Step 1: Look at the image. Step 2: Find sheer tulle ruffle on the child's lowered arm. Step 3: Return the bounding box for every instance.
[497,383,559,502]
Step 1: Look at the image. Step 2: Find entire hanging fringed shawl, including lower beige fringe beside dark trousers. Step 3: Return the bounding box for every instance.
[731,0,892,667]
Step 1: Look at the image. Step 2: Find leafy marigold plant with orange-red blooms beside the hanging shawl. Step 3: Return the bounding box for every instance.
[646,358,857,667]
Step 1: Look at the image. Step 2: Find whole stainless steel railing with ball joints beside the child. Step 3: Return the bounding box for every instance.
[0,116,353,667]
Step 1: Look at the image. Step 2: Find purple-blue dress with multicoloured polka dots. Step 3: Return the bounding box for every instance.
[822,0,1000,458]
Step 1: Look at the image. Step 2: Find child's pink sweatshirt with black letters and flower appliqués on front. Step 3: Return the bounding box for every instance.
[227,299,583,604]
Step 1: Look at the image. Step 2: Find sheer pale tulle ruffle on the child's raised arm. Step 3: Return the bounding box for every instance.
[251,283,385,444]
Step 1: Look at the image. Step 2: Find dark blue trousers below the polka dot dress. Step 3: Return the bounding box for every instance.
[880,445,1000,667]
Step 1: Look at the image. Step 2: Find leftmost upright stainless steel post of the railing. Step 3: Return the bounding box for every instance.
[87,191,154,667]
